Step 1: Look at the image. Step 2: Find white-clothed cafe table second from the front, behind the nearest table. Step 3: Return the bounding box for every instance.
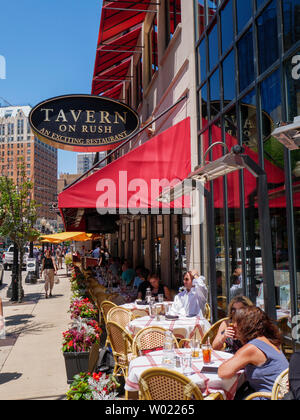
[126,315,211,339]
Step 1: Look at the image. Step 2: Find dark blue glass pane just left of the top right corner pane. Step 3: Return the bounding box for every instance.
[257,0,279,73]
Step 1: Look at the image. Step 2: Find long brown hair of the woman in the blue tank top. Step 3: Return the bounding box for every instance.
[235,306,282,347]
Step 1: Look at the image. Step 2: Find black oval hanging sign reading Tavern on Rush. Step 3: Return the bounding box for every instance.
[29,95,140,152]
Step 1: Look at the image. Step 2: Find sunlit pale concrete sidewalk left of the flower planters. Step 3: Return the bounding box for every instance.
[0,270,71,400]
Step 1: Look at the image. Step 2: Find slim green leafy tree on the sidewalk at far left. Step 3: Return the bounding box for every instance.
[0,160,39,302]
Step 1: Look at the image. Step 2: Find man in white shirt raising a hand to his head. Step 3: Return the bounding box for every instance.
[171,271,208,318]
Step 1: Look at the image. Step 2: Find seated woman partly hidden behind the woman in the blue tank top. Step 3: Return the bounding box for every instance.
[212,296,253,354]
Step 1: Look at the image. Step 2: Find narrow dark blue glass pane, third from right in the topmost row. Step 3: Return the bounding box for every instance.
[238,28,254,92]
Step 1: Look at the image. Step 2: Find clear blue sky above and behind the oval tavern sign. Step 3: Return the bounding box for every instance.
[0,0,102,173]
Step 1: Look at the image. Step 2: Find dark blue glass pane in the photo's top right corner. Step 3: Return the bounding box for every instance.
[282,0,300,50]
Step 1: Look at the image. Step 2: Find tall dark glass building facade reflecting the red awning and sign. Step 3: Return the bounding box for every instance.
[195,0,300,342]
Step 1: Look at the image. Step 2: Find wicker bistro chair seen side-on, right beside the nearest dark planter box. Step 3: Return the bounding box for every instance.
[106,321,133,379]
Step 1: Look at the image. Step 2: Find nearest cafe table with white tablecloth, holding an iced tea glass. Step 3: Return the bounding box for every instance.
[125,349,244,400]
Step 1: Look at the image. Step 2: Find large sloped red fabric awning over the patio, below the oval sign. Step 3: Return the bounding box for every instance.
[58,118,191,231]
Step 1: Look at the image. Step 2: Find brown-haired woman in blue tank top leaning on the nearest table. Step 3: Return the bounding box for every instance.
[218,306,289,398]
